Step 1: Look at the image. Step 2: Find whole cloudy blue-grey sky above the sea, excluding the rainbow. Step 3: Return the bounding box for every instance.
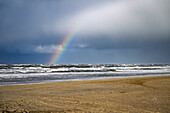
[0,0,170,64]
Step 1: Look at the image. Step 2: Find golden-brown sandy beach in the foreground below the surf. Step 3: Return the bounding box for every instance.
[0,76,170,113]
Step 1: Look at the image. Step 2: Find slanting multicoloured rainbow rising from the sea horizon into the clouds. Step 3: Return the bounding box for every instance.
[49,28,78,64]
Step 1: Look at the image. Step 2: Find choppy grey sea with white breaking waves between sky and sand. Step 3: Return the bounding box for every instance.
[0,64,170,85]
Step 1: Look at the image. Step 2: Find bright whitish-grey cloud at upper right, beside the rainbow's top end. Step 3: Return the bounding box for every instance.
[64,0,170,38]
